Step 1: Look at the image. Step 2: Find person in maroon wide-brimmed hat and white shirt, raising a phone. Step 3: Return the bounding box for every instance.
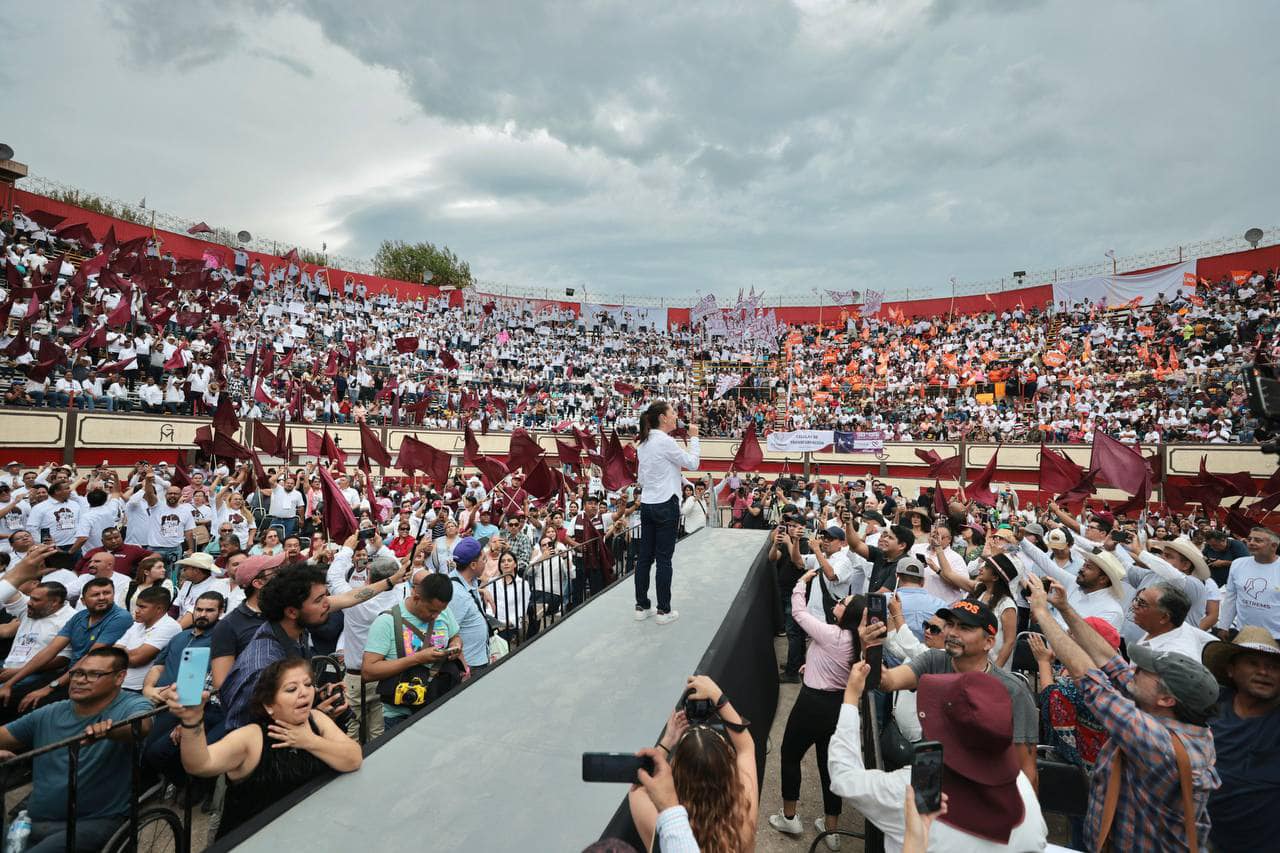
[829,662,1048,853]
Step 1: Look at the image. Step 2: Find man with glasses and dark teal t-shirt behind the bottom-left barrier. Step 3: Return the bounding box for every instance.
[0,647,151,853]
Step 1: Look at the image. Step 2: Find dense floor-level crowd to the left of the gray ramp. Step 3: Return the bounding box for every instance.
[0,457,680,850]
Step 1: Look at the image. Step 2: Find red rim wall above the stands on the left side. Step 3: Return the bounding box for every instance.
[13,190,462,305]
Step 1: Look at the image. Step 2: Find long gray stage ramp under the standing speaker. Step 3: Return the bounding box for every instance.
[237,529,767,853]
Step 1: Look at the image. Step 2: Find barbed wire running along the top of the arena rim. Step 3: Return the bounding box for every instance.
[22,175,1280,307]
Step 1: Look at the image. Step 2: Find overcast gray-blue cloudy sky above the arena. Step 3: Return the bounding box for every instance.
[0,0,1280,297]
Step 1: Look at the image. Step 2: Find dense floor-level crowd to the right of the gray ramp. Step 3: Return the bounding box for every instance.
[755,473,1280,850]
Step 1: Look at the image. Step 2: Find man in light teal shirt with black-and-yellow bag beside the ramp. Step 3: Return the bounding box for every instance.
[360,574,462,729]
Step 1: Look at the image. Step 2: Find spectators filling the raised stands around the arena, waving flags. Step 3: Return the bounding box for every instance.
[0,204,1276,443]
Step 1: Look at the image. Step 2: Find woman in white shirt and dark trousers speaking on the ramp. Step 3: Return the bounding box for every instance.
[635,400,699,625]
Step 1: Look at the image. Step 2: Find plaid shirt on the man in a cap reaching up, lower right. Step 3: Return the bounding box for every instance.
[1079,654,1222,853]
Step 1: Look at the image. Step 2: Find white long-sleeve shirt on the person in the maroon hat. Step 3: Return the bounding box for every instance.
[827,704,1048,853]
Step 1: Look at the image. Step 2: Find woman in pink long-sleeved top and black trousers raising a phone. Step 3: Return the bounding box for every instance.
[769,570,867,835]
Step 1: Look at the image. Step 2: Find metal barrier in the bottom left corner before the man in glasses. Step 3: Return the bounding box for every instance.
[0,707,195,853]
